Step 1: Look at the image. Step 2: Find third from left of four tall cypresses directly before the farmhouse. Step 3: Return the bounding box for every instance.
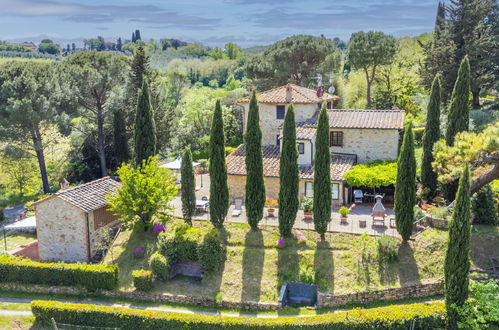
[279,104,299,237]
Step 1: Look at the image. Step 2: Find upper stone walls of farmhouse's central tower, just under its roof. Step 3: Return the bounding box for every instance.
[243,103,320,145]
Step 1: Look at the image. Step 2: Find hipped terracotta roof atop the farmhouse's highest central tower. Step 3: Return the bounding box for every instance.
[236,84,339,104]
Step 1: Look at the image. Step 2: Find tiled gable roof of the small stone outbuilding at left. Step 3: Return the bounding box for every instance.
[32,176,120,212]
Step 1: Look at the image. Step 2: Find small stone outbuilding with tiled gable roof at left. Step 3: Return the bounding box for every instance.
[33,177,120,262]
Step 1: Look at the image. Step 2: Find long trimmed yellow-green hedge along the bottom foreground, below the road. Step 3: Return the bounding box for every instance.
[31,300,445,330]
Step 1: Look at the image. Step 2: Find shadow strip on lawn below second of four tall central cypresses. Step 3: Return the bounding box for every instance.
[241,229,265,301]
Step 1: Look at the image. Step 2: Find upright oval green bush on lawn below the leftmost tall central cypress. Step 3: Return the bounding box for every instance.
[197,229,225,272]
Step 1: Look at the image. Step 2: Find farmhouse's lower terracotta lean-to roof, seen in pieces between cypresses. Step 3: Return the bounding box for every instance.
[226,145,356,181]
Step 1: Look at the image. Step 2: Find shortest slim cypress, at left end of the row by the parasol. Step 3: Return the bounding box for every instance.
[180,147,196,226]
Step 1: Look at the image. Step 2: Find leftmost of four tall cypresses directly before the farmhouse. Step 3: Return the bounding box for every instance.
[209,100,229,228]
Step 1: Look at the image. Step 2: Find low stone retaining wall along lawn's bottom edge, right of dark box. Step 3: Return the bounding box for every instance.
[317,281,444,307]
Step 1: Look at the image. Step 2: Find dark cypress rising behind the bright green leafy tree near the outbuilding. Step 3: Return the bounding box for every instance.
[134,80,156,166]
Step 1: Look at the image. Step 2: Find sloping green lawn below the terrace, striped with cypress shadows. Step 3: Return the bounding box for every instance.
[104,222,499,302]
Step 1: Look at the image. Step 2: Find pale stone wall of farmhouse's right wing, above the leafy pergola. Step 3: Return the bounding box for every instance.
[331,129,399,164]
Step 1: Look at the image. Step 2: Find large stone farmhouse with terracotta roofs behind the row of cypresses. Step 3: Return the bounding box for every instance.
[227,84,405,204]
